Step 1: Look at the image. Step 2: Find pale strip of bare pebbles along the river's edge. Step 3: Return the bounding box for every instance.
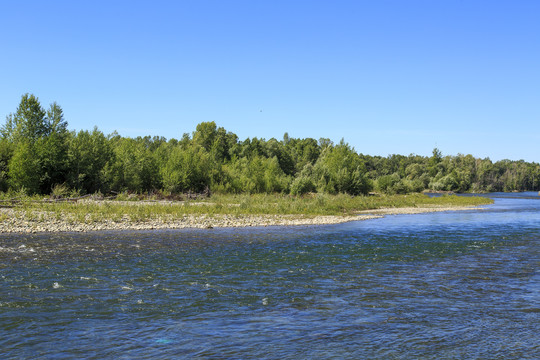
[0,206,478,233]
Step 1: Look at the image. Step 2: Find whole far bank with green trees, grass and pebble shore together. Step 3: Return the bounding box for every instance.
[0,93,528,233]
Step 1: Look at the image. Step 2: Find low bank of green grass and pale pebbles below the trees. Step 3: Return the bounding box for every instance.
[0,194,493,233]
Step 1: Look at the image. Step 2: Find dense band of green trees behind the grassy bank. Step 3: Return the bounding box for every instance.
[0,94,540,195]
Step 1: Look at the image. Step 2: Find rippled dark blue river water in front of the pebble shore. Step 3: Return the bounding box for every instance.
[0,193,540,359]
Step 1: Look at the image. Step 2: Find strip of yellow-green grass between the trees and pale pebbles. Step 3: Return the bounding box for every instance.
[8,194,492,223]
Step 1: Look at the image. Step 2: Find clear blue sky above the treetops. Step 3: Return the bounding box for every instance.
[0,0,540,162]
